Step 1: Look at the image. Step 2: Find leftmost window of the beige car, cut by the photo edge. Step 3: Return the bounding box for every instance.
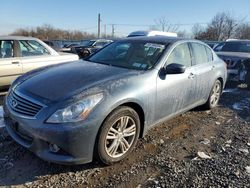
[0,40,14,58]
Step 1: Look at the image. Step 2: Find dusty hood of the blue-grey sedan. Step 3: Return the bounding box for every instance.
[17,61,139,101]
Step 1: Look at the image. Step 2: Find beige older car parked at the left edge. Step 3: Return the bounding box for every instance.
[0,36,79,90]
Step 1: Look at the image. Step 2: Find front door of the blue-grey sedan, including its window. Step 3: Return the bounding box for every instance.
[156,43,195,119]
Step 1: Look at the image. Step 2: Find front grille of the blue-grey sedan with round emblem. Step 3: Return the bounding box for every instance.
[8,91,43,117]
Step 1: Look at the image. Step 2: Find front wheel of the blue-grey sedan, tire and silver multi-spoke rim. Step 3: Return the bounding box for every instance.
[97,106,140,165]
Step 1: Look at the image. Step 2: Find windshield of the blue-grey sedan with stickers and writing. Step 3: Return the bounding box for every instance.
[88,41,166,70]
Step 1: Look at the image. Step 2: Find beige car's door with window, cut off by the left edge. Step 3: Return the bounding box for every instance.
[0,40,22,89]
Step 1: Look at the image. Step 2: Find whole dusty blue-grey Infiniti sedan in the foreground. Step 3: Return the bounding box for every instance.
[4,36,227,164]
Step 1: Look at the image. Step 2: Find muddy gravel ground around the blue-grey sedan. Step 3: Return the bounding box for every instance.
[0,84,250,188]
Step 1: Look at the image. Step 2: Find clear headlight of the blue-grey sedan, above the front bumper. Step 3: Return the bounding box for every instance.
[47,93,103,123]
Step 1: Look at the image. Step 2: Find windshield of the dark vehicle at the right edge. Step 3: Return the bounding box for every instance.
[221,42,250,53]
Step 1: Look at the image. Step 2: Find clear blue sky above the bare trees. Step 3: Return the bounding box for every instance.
[0,0,250,35]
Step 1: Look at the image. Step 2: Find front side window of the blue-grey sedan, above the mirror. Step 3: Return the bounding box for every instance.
[167,43,191,67]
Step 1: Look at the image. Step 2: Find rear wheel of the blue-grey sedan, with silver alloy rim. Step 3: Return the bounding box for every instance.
[203,80,222,110]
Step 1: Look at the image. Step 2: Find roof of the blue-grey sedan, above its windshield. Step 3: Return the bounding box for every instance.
[118,36,193,44]
